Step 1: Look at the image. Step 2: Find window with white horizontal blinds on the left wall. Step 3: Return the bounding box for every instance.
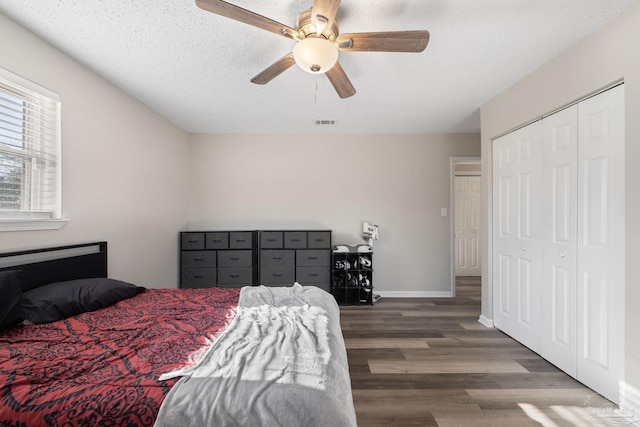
[0,68,64,231]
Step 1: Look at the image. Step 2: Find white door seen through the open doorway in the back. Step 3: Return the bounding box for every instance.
[454,176,482,276]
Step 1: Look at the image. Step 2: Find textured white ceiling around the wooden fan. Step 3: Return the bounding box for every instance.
[0,0,640,133]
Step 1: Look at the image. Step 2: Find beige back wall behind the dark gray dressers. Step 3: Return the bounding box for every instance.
[189,134,480,295]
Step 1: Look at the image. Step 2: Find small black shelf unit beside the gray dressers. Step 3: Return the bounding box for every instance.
[331,251,373,305]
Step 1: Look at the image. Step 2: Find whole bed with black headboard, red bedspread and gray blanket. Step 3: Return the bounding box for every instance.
[0,242,356,427]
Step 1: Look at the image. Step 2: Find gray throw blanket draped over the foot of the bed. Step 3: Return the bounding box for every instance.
[155,284,356,427]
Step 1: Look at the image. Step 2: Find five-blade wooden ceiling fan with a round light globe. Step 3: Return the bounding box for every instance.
[196,0,429,98]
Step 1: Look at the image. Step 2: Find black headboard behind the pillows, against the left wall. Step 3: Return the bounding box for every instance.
[0,242,107,292]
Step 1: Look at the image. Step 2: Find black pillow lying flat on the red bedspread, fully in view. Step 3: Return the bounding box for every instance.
[22,278,146,324]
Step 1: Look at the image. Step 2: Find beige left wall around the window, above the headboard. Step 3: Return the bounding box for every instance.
[0,14,189,287]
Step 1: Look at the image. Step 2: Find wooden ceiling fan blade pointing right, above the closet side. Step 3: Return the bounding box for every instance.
[336,31,429,52]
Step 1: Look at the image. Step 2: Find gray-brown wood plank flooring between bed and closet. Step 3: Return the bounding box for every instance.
[340,278,630,427]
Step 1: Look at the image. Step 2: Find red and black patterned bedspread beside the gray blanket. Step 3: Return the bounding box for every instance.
[0,288,240,427]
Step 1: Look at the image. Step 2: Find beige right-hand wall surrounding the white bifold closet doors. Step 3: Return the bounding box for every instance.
[481,5,640,416]
